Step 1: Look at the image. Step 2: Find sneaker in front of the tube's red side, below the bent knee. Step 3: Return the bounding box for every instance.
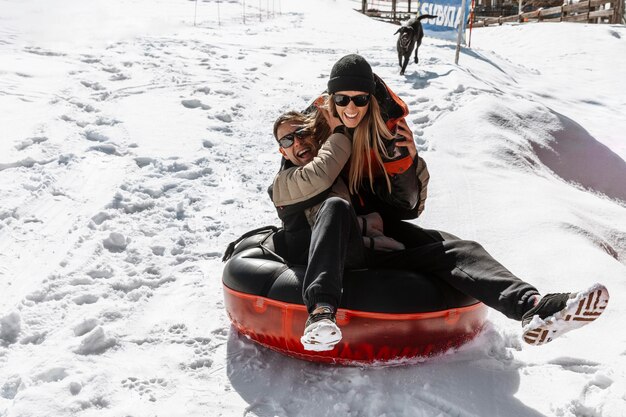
[300,307,341,352]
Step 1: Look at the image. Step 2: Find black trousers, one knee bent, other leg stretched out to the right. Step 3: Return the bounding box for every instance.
[303,198,539,320]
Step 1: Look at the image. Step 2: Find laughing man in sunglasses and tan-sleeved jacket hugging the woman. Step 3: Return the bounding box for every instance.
[270,109,404,351]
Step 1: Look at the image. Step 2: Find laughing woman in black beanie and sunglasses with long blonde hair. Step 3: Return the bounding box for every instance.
[310,54,608,345]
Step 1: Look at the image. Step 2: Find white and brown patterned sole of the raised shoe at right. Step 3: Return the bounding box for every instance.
[522,284,609,346]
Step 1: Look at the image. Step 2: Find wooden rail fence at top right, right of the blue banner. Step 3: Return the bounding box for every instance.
[474,0,624,27]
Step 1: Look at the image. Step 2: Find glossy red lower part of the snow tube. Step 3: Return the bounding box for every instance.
[224,285,487,365]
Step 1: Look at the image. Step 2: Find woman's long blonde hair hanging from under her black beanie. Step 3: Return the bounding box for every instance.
[314,94,393,194]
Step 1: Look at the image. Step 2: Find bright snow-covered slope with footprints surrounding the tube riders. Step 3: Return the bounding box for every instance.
[0,0,626,417]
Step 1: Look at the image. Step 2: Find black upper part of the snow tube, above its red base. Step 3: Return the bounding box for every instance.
[222,232,477,314]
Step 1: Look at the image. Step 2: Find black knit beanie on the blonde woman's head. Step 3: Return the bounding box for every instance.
[328,54,376,94]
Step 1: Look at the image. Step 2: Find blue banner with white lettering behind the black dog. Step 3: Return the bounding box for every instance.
[417,0,472,43]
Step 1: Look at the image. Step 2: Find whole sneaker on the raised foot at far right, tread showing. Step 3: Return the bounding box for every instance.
[522,284,609,346]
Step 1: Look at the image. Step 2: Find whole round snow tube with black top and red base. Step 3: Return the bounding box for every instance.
[222,230,487,365]
